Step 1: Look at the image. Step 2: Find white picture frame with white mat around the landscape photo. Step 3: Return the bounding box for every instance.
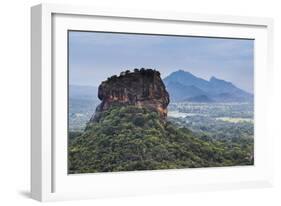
[31,4,273,201]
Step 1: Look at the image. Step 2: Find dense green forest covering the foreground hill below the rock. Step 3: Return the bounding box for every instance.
[68,106,254,174]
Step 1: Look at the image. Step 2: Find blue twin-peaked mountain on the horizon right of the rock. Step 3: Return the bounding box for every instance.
[164,70,253,102]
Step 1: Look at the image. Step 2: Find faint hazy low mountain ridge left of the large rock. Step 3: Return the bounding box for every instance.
[69,85,98,100]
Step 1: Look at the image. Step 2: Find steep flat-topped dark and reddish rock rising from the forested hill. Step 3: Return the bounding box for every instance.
[91,69,170,122]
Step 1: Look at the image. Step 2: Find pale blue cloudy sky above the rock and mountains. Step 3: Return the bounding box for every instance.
[68,31,254,93]
